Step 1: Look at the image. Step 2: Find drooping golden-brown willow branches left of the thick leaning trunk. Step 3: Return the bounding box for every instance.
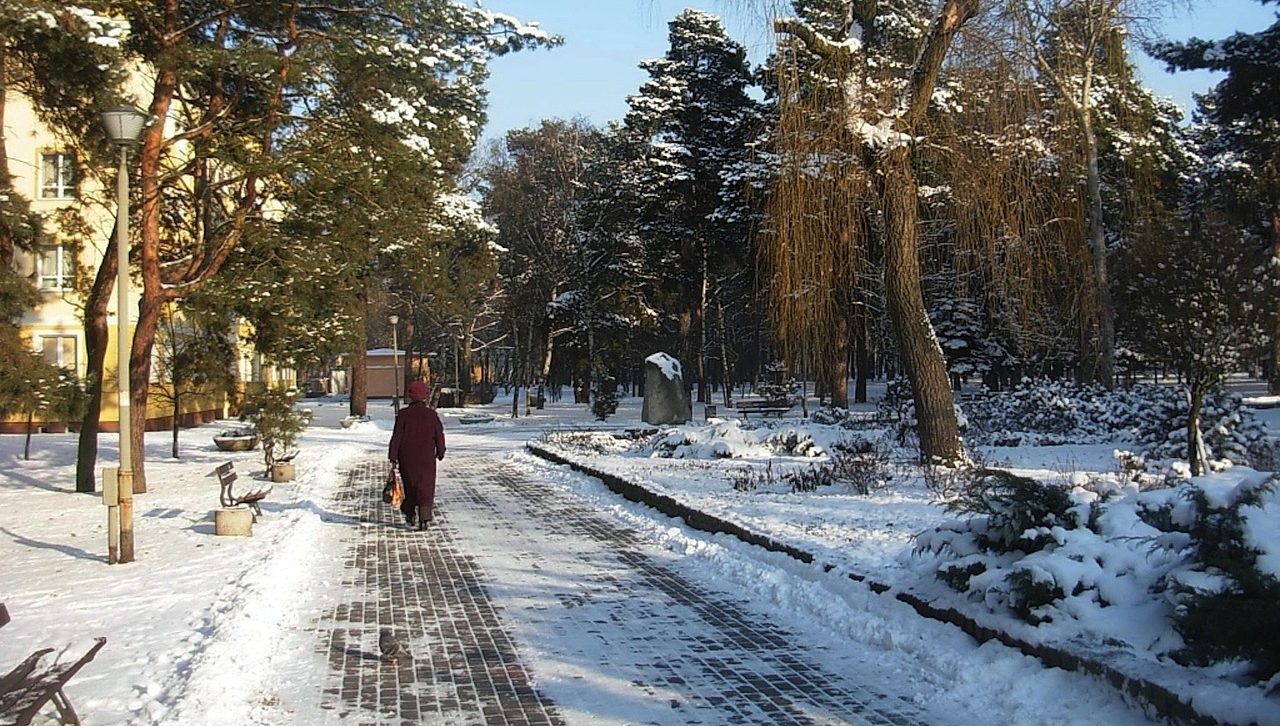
[759,0,878,407]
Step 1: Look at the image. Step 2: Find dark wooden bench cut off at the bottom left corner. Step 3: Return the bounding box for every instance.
[0,603,106,726]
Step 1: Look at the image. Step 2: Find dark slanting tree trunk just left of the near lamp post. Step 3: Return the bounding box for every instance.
[76,225,115,493]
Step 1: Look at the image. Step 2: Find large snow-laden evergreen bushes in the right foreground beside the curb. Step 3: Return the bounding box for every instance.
[915,467,1280,691]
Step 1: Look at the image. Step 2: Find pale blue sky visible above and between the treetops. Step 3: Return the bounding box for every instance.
[484,0,1275,138]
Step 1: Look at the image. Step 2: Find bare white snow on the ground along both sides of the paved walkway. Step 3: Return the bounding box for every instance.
[0,384,1280,723]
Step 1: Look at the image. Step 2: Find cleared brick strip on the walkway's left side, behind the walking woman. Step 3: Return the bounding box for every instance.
[321,461,564,726]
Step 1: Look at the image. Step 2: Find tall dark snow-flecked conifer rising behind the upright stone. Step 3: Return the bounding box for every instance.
[626,10,759,402]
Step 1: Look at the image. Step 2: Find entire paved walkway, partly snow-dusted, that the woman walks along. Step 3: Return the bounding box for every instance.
[312,456,951,725]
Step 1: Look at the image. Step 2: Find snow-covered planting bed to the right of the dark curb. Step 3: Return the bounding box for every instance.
[522,391,1280,723]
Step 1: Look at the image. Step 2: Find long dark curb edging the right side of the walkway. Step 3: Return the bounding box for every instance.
[525,442,1222,726]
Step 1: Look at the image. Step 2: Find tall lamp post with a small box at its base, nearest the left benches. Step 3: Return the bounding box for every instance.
[102,106,147,563]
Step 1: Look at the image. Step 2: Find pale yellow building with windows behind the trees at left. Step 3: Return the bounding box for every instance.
[0,93,294,433]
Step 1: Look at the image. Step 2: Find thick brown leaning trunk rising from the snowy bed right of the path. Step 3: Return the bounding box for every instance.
[874,149,964,464]
